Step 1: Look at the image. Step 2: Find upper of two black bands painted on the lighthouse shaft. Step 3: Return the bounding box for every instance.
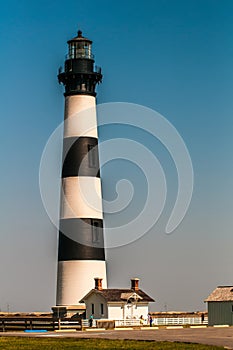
[62,137,100,178]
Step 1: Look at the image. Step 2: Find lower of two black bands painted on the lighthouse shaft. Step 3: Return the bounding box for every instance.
[58,218,105,261]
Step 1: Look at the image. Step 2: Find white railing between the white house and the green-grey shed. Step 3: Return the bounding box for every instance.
[152,317,208,326]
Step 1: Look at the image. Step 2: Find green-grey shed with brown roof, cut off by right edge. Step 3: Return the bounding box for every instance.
[205,286,233,326]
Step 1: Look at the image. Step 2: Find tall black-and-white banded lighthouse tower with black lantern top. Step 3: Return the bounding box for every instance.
[57,31,107,306]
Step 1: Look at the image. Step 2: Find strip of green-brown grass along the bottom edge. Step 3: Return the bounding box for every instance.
[0,337,224,350]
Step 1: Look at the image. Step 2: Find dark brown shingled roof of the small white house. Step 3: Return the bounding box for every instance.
[80,289,154,303]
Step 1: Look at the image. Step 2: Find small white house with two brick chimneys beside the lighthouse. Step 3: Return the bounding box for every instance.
[80,278,154,320]
